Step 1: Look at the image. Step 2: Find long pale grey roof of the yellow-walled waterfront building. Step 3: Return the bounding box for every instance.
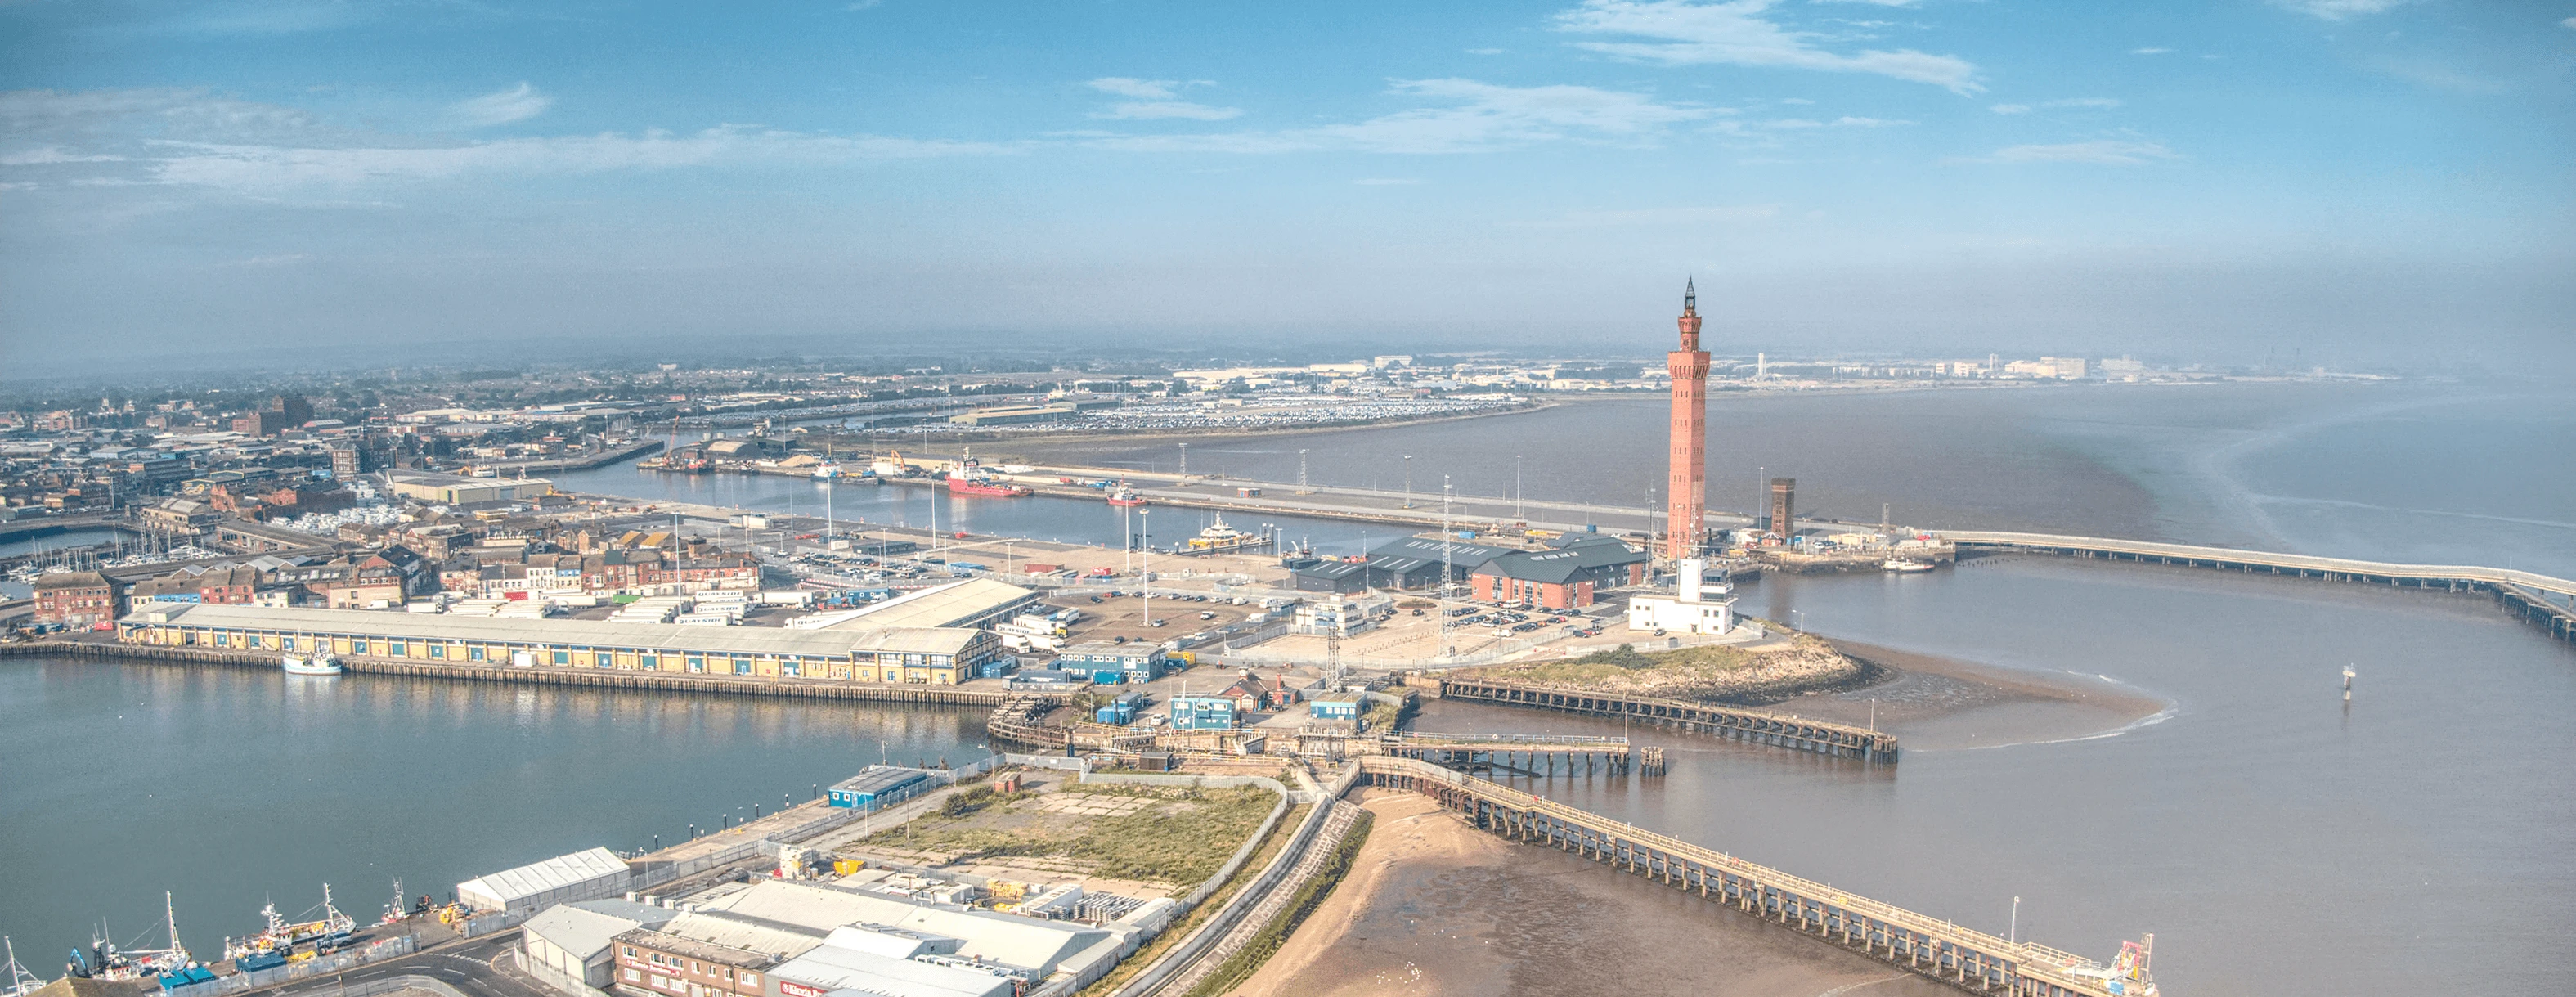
[150,605,932,657]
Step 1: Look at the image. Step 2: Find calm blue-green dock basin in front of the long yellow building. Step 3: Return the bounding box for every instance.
[0,657,986,977]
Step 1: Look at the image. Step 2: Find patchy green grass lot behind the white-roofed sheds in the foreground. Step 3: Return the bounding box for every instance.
[858,784,1277,894]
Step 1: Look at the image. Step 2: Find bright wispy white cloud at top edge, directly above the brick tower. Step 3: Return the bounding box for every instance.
[1556,0,1984,96]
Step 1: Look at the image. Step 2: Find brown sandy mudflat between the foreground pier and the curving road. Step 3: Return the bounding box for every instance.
[1234,791,1950,997]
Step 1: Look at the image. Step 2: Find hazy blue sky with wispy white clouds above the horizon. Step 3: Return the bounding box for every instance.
[0,0,2576,379]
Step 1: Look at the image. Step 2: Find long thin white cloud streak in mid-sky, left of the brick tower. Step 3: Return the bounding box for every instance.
[1089,77,1718,155]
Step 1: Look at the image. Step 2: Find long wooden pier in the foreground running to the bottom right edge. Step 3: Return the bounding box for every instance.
[1360,755,2112,997]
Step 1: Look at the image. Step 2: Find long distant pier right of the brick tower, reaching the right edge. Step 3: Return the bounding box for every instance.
[1940,531,2576,641]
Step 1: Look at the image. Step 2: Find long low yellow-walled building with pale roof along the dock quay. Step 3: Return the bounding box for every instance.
[116,603,1002,685]
